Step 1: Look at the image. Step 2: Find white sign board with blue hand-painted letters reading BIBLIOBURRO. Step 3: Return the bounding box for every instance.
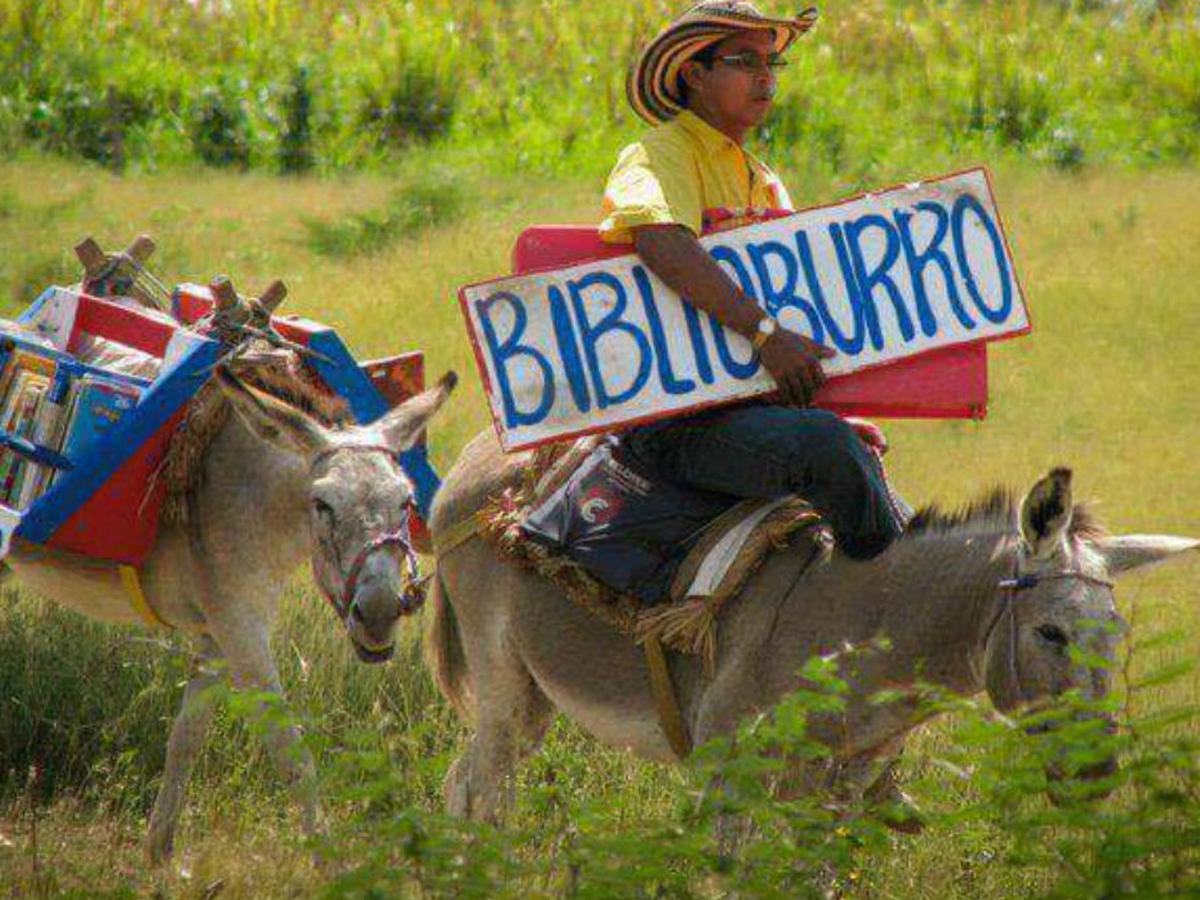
[460,169,1030,451]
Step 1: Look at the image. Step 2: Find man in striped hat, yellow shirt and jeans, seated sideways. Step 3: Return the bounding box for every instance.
[590,0,907,558]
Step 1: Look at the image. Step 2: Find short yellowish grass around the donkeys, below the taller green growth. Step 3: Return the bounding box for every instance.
[0,160,1200,898]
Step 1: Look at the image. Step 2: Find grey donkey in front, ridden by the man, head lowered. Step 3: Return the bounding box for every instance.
[426,436,1200,820]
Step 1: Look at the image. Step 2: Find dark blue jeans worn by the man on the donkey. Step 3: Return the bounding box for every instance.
[622,406,910,559]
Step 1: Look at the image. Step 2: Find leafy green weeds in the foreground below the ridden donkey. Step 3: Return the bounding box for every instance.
[302,643,1200,900]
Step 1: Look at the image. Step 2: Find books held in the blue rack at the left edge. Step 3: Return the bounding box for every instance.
[0,344,142,510]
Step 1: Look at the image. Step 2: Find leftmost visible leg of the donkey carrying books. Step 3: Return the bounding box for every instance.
[146,637,222,865]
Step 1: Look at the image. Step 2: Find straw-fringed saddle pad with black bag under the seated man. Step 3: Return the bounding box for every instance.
[476,437,832,670]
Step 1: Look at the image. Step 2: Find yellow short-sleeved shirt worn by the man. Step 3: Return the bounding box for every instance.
[600,109,792,244]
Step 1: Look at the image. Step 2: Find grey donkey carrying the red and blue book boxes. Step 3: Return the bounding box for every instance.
[6,370,456,863]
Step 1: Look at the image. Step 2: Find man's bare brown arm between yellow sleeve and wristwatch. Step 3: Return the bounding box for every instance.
[634,226,763,337]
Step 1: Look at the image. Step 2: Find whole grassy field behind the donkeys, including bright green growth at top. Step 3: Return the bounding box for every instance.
[0,0,1200,899]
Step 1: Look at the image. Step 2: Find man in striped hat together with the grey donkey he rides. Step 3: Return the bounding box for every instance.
[426,0,1200,828]
